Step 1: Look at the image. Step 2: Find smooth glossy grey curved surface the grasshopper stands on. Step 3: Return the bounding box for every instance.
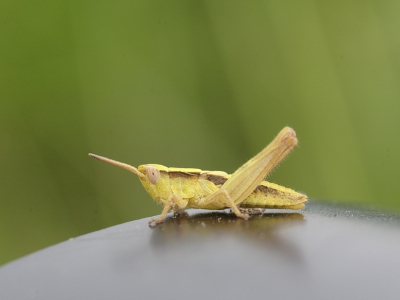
[0,202,400,299]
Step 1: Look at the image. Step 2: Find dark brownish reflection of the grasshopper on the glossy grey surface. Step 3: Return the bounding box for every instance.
[151,209,306,261]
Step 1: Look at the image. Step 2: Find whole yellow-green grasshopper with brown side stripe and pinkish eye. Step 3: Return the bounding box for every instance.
[89,127,307,225]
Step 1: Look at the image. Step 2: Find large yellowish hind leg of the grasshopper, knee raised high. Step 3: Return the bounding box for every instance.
[198,127,297,220]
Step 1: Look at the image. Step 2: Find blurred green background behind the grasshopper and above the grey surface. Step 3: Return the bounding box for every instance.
[0,0,400,264]
